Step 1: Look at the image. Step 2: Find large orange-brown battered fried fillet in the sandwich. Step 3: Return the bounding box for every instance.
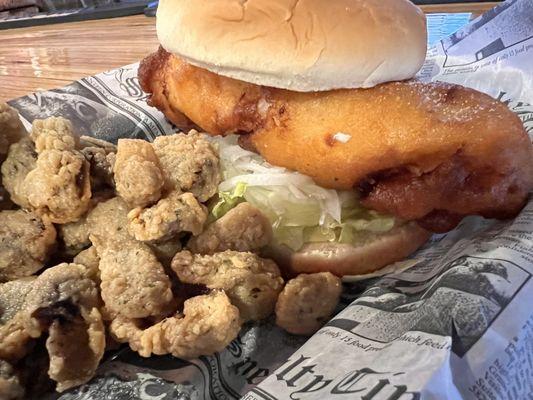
[139,49,533,231]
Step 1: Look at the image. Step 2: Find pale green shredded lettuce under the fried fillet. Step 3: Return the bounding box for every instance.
[211,137,395,250]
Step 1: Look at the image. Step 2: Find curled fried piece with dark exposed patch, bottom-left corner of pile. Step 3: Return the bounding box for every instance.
[0,264,105,391]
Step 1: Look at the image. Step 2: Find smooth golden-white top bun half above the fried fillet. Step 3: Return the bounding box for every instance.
[157,0,427,92]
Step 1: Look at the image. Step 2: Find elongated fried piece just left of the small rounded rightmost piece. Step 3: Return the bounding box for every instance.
[171,250,283,321]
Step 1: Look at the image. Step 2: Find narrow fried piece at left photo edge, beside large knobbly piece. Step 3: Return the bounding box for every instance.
[2,137,37,208]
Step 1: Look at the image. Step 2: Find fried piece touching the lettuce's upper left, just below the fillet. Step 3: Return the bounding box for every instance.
[153,130,221,203]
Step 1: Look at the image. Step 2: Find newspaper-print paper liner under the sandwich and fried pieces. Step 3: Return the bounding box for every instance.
[10,0,533,400]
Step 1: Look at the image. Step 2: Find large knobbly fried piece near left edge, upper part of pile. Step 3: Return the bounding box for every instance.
[22,150,91,224]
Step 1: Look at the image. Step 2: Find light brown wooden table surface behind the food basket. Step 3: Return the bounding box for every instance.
[0,2,498,101]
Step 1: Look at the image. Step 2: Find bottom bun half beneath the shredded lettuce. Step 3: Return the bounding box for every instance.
[264,222,431,277]
